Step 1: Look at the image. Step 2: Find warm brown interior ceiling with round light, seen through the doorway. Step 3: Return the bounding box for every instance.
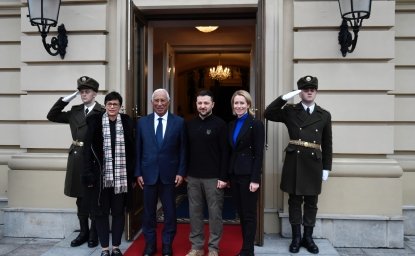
[152,20,255,73]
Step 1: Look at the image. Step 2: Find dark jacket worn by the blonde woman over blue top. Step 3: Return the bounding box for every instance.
[228,115,265,183]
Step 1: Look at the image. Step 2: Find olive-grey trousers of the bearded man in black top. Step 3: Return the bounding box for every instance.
[187,176,224,251]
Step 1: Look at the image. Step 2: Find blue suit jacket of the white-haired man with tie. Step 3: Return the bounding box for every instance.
[135,113,186,185]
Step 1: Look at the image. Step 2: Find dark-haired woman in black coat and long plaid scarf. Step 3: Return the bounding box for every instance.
[82,92,135,256]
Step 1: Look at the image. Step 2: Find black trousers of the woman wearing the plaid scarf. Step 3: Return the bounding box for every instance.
[94,188,126,248]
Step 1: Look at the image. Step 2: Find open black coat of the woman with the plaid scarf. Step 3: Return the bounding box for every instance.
[81,113,135,214]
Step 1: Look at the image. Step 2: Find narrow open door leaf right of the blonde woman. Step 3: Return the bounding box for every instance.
[253,0,265,246]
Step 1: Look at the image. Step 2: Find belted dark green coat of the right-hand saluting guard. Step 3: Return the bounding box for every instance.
[264,96,333,195]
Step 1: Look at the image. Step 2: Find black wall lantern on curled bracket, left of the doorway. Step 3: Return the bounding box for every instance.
[27,0,68,59]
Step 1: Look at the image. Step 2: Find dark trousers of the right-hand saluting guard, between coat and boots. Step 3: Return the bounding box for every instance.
[288,194,318,227]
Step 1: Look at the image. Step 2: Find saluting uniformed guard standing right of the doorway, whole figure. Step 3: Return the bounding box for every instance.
[264,76,333,253]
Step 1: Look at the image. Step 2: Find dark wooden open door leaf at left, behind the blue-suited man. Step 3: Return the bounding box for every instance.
[125,1,147,240]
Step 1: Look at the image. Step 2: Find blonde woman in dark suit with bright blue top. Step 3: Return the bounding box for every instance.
[228,90,265,256]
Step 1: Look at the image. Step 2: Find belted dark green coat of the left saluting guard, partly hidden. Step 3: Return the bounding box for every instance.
[47,98,105,197]
